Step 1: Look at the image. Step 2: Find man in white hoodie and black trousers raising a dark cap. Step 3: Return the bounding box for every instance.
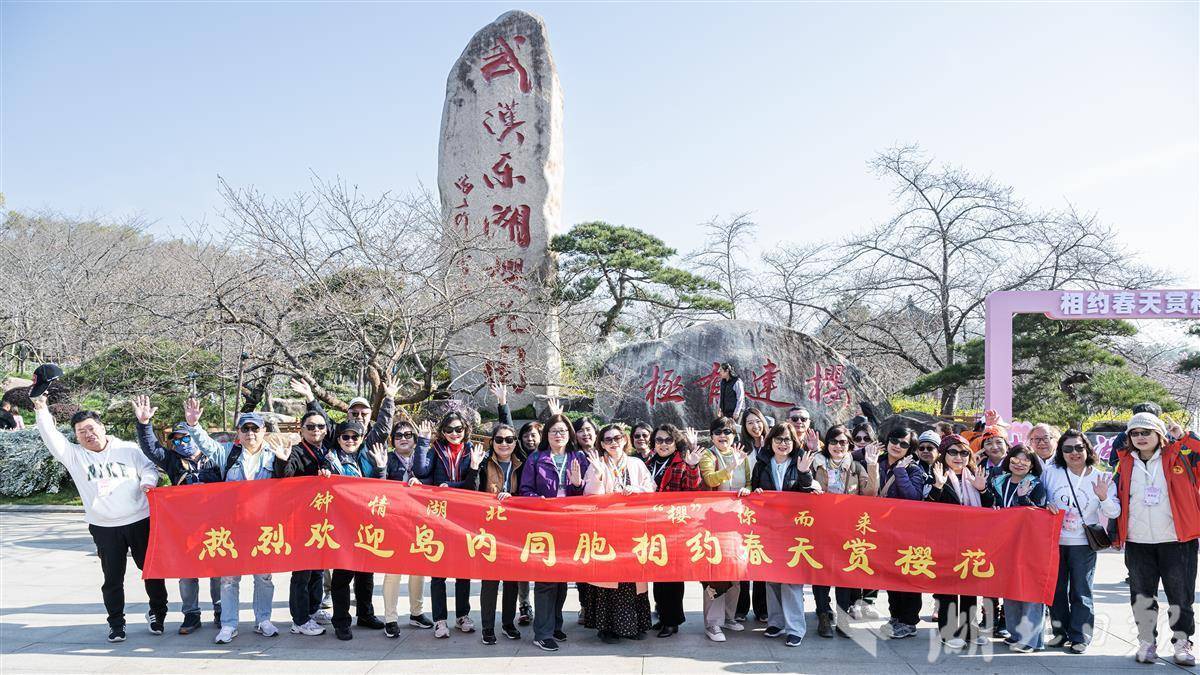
[32,395,167,643]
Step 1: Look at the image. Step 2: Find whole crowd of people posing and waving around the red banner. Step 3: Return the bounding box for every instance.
[23,366,1200,665]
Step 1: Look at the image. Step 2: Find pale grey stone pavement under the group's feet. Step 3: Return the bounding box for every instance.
[0,512,1187,675]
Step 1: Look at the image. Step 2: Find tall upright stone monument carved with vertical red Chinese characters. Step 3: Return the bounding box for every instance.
[438,11,563,410]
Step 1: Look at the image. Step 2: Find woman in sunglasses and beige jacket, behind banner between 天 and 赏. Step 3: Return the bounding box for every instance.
[812,424,880,638]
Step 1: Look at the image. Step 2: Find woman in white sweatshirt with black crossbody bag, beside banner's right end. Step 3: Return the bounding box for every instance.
[1030,428,1121,653]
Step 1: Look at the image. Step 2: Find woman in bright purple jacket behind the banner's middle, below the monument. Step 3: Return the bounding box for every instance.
[518,414,588,651]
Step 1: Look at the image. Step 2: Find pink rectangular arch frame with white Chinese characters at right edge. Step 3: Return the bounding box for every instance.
[984,288,1200,419]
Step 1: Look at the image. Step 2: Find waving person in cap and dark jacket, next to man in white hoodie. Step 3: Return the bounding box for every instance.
[130,395,221,635]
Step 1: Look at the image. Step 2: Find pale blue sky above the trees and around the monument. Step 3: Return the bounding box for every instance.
[0,2,1200,278]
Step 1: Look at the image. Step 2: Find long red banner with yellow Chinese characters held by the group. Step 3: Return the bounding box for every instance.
[145,477,1062,603]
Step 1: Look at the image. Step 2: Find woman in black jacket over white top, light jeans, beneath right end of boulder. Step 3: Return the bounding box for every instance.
[738,422,820,647]
